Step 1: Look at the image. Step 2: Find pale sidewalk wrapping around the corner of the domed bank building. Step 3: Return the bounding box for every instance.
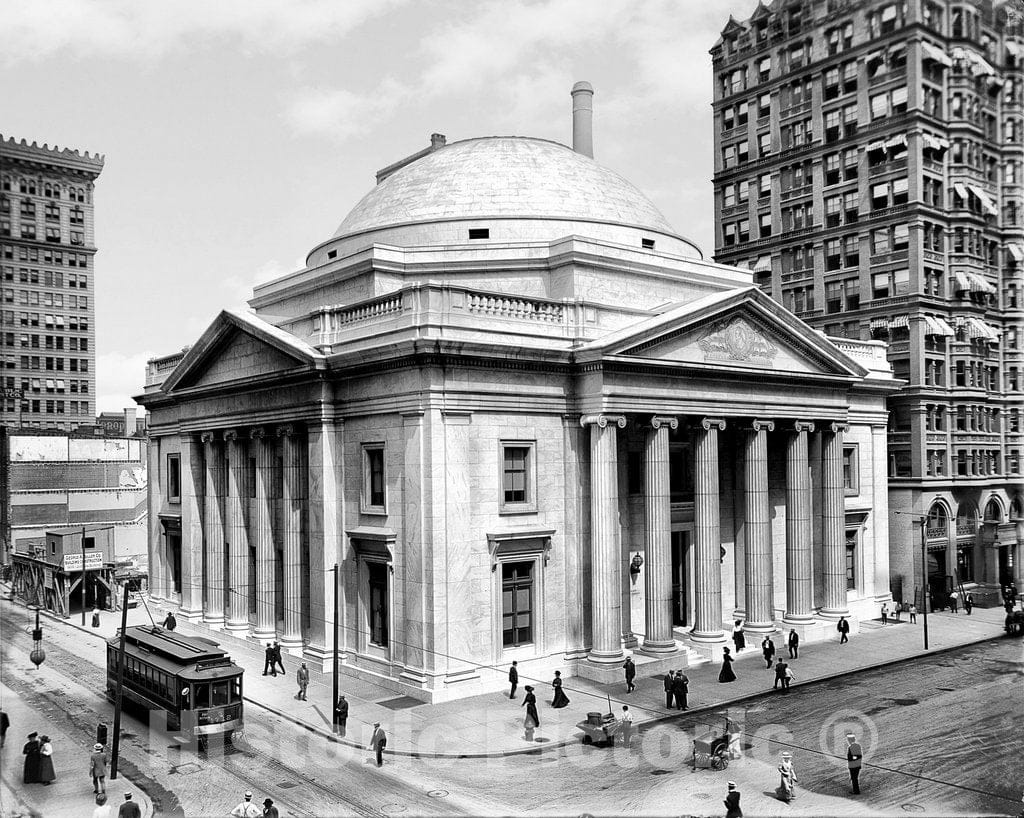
[22,589,1005,758]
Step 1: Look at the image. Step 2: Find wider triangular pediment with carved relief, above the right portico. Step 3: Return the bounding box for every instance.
[594,288,865,377]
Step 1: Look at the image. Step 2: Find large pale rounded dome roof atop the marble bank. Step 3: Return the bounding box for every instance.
[335,136,676,239]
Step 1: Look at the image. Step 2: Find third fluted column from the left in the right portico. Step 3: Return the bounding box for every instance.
[692,418,725,642]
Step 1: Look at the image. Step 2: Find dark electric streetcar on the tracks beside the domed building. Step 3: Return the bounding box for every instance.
[106,626,244,743]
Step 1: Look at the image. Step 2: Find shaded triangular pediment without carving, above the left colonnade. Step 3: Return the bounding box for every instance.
[163,310,325,392]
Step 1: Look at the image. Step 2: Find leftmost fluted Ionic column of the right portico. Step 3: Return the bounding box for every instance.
[580,415,626,664]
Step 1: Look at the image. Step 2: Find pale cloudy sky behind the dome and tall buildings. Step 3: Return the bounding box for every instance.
[0,0,756,412]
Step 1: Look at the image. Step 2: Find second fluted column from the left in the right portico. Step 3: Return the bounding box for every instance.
[643,416,679,653]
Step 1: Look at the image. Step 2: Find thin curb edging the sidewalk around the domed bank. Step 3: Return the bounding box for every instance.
[22,593,1006,760]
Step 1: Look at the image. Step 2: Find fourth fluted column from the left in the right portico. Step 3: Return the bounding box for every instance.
[743,421,775,633]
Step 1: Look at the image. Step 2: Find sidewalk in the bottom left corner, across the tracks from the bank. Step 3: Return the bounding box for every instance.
[0,684,153,818]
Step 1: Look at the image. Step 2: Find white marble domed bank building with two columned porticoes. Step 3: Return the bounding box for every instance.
[138,83,896,700]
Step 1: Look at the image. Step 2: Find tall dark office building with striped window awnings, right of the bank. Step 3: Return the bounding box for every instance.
[712,0,1024,604]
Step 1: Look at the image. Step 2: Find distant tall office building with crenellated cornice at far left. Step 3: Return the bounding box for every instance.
[0,136,103,431]
